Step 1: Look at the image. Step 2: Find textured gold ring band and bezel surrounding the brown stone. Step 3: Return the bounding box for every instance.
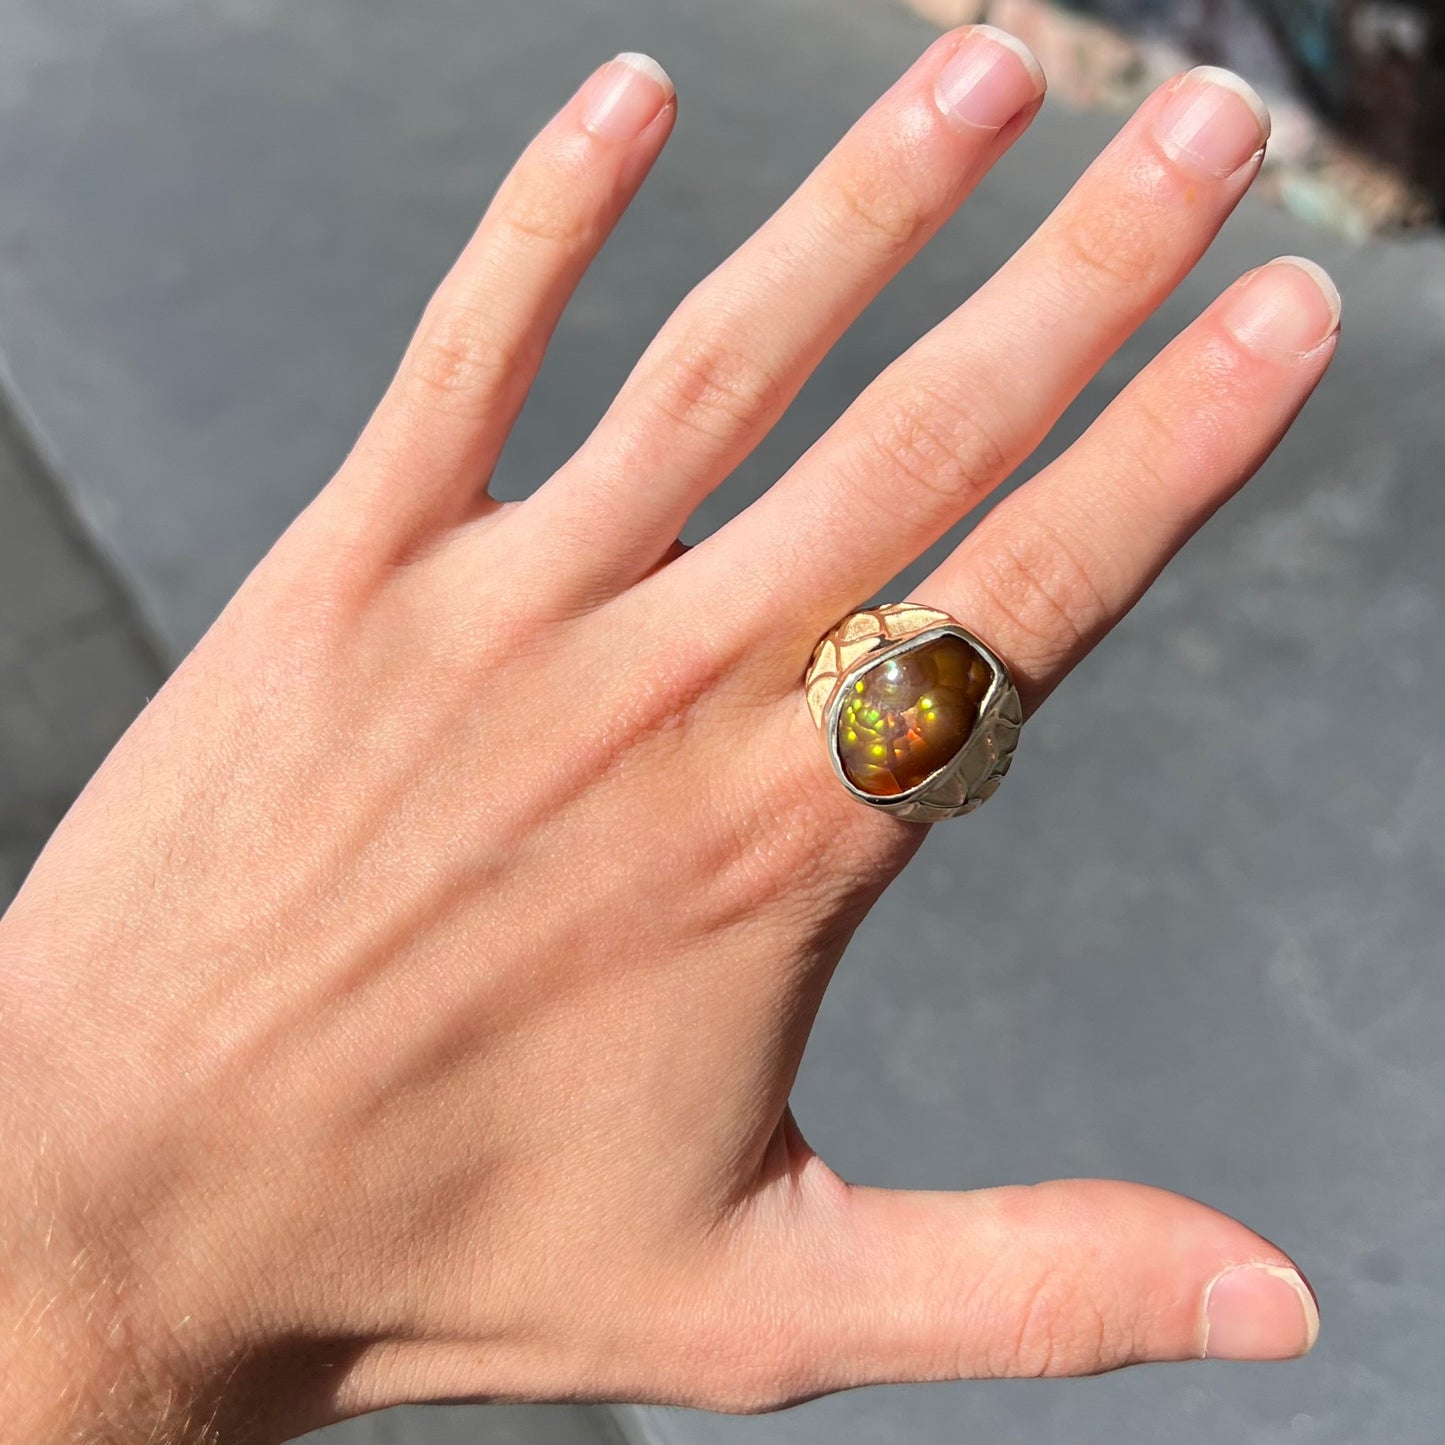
[803,603,1023,822]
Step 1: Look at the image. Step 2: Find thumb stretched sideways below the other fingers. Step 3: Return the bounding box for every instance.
[734,1157,1319,1397]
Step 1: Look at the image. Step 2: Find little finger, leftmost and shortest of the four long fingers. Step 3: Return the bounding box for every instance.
[336,53,676,539]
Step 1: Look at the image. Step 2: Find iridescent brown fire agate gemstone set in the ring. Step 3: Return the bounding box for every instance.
[838,633,993,798]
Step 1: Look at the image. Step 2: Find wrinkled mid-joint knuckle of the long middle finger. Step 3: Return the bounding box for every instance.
[873,386,1009,512]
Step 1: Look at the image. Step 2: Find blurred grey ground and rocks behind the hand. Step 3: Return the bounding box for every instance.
[0,0,1445,1445]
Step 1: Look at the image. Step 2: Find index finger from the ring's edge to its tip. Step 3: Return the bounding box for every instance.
[919,257,1340,709]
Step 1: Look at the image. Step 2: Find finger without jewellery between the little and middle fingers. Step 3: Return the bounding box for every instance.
[529,26,1043,604]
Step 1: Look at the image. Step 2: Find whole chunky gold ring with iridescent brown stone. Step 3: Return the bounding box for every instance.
[803,603,1023,822]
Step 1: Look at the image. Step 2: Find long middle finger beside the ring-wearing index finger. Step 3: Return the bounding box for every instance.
[688,69,1267,637]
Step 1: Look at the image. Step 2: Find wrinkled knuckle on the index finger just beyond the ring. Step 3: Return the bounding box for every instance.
[975,520,1108,668]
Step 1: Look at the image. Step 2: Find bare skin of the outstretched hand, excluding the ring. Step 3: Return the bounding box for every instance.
[0,30,1338,1445]
